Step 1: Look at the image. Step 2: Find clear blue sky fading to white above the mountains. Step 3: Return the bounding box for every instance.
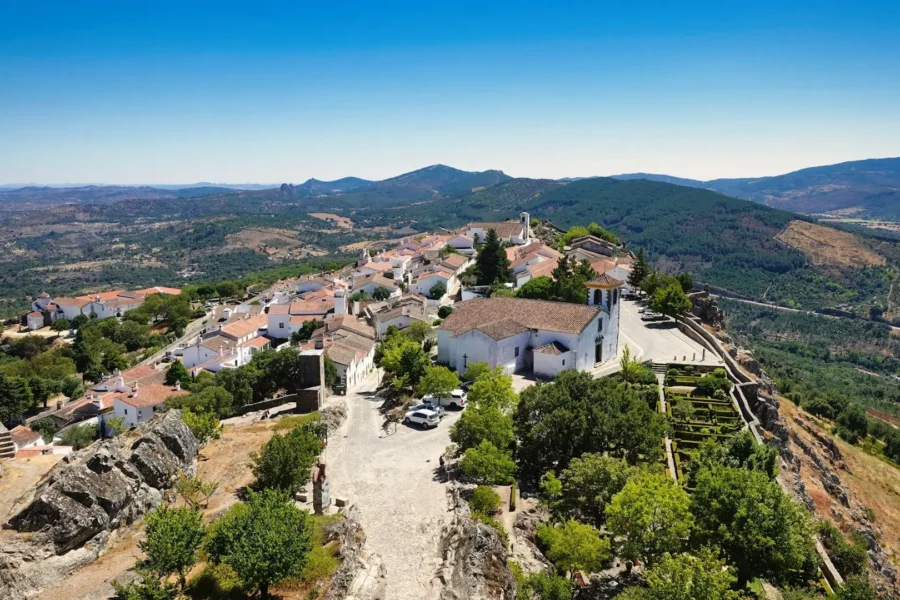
[0,0,900,183]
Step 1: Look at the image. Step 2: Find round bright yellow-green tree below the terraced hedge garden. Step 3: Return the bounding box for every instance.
[606,473,693,564]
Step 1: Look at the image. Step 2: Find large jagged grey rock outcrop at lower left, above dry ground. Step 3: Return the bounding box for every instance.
[0,411,199,599]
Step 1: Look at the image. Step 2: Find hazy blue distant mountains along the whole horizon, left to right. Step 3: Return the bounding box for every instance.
[0,158,900,219]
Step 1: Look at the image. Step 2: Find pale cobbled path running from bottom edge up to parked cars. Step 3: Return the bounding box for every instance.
[325,374,459,600]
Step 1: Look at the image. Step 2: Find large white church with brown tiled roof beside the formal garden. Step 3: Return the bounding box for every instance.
[437,298,618,377]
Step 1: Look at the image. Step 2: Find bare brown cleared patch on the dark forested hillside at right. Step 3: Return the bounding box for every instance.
[775,221,885,268]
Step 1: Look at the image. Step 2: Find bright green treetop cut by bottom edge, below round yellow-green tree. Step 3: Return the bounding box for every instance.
[620,548,742,600]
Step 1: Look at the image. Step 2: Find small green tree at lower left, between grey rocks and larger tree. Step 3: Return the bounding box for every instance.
[140,504,206,590]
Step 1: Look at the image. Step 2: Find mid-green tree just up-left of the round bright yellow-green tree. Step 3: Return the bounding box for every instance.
[556,453,635,528]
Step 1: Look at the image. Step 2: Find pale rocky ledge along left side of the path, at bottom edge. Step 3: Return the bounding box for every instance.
[324,509,387,600]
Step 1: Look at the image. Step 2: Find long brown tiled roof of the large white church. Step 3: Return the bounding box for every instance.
[438,298,600,337]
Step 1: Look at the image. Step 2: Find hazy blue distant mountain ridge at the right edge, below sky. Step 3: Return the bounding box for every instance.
[613,158,900,218]
